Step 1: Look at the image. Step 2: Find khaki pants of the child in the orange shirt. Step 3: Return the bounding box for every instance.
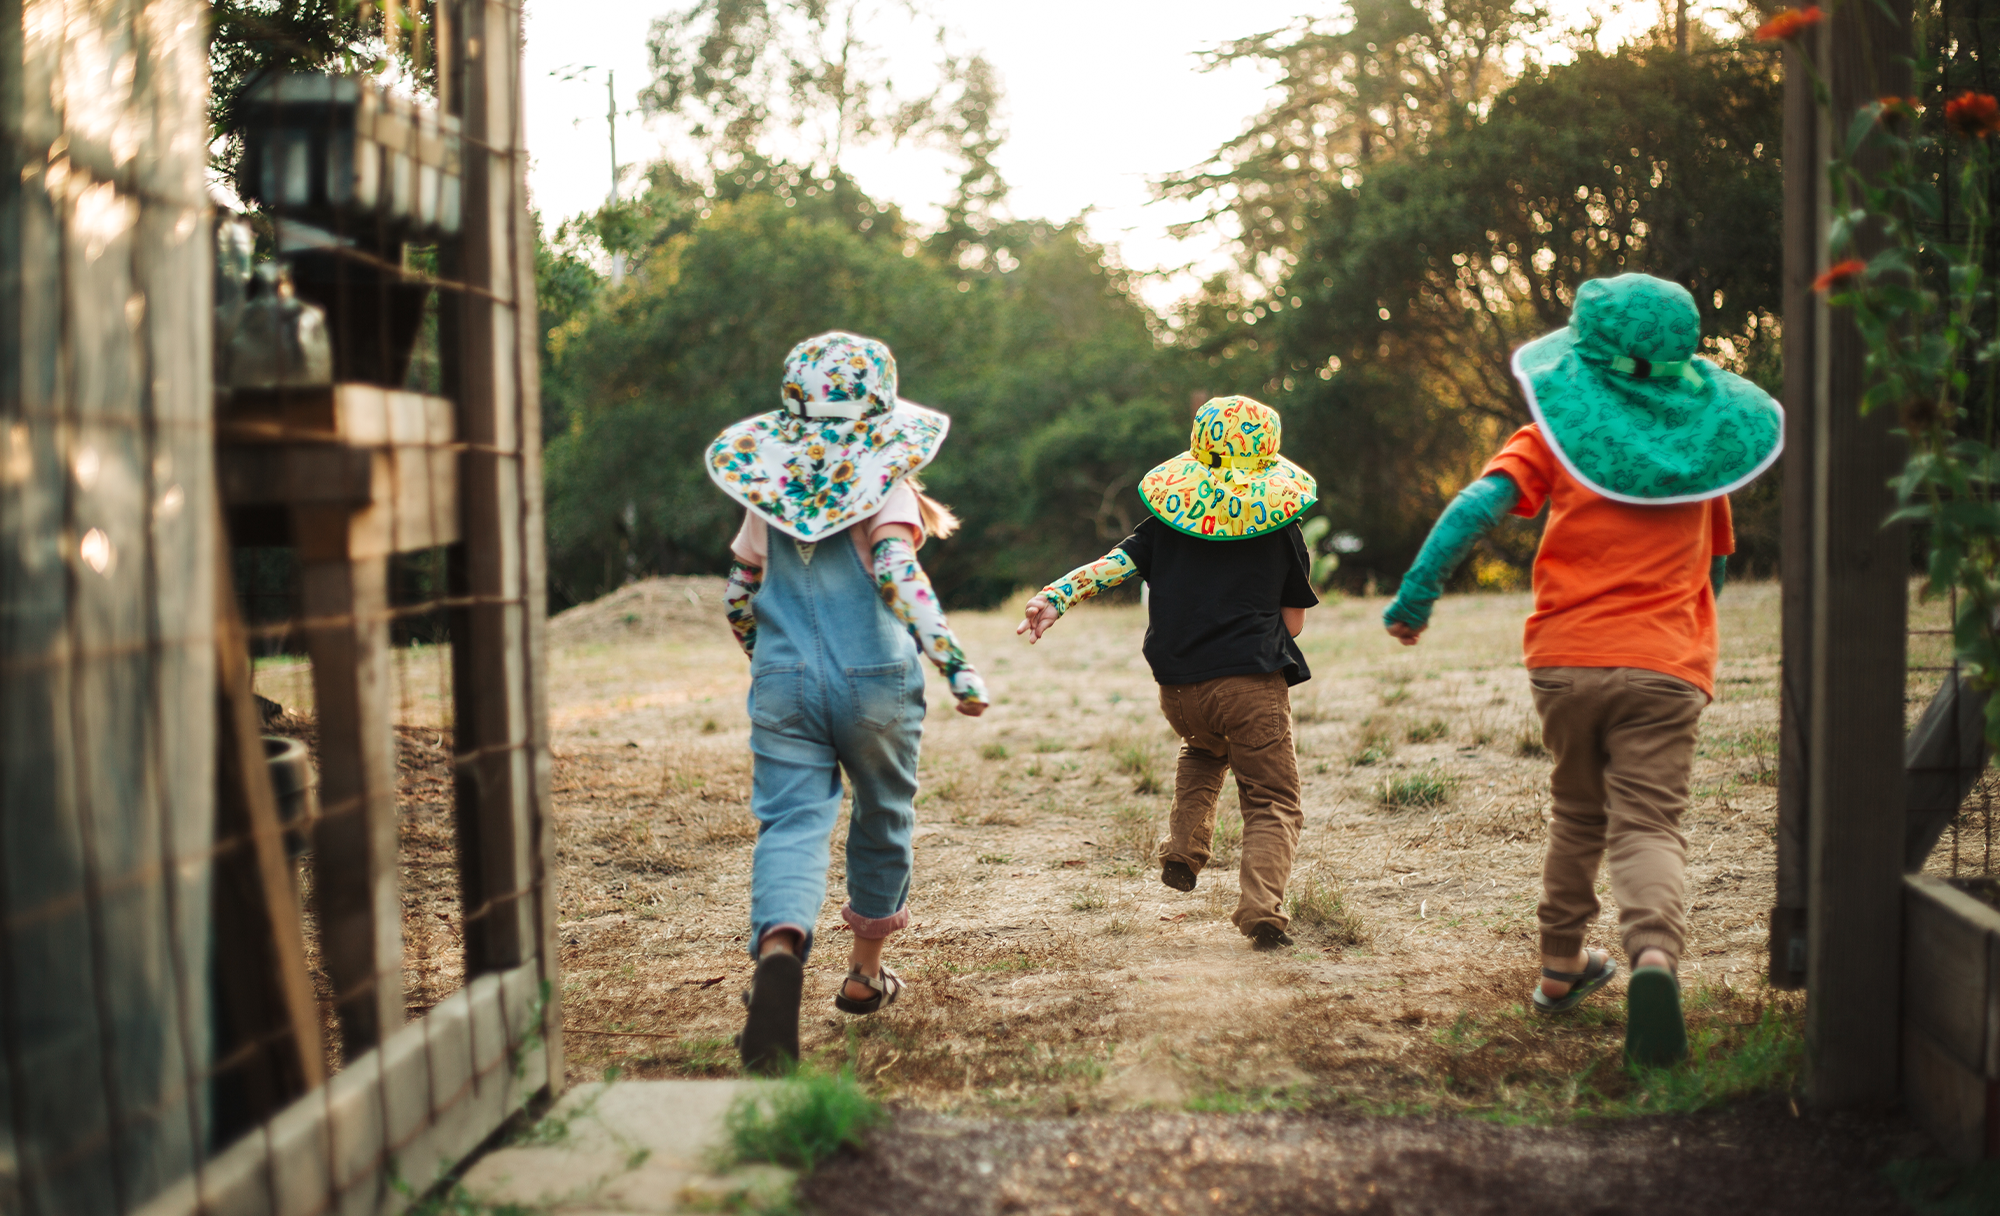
[1528,668,1708,960]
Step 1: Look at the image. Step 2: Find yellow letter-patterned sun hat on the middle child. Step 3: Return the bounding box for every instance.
[1138,396,1320,540]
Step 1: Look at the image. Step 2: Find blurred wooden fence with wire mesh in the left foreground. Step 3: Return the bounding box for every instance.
[0,0,562,1216]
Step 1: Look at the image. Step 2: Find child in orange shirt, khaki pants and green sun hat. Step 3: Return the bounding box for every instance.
[1382,274,1784,1064]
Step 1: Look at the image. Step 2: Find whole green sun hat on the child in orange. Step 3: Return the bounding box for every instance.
[1514,274,1784,504]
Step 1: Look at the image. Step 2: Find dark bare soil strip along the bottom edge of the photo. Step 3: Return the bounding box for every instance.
[802,1102,1910,1216]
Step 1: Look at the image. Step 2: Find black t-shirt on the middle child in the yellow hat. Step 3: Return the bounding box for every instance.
[1118,518,1320,684]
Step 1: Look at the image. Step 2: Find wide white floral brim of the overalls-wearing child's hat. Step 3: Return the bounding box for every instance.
[702,400,952,544]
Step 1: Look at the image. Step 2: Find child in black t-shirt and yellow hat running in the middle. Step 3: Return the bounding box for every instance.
[1014,396,1320,950]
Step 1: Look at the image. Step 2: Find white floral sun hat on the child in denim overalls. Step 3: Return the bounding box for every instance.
[704,330,952,544]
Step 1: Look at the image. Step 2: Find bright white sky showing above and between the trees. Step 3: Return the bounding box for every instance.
[526,0,1706,306]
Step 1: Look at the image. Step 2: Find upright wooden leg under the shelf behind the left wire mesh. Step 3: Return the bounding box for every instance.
[300,558,404,1058]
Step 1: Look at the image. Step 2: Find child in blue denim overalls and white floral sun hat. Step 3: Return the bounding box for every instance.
[708,332,986,1072]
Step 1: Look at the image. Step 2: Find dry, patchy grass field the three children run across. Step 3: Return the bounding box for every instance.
[552,580,1792,1112]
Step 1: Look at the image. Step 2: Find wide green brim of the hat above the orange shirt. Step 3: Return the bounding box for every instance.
[1512,328,1784,506]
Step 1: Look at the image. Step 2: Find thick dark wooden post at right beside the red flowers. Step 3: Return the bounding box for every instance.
[1806,4,1910,1106]
